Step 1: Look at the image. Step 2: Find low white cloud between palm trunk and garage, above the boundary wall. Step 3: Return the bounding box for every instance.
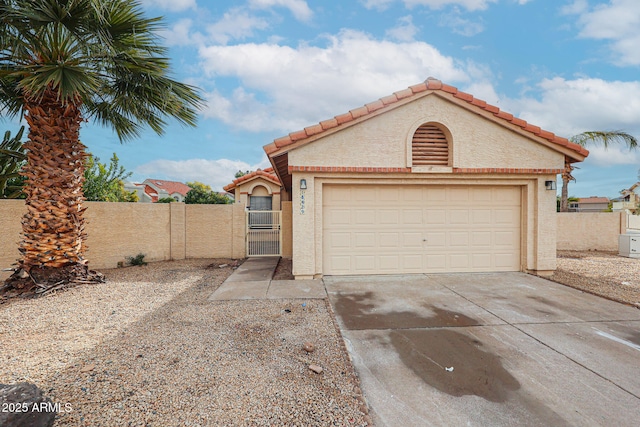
[135,157,271,191]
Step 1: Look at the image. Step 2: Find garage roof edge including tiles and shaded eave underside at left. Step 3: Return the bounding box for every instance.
[264,77,589,187]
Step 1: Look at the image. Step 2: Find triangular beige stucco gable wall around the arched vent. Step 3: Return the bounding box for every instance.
[289,94,564,169]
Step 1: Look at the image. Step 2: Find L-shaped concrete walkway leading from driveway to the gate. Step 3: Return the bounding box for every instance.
[209,257,327,301]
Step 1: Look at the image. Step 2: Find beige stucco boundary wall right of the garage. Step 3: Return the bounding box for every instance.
[556,212,627,251]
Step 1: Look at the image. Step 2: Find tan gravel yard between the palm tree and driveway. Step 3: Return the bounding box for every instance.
[0,260,369,426]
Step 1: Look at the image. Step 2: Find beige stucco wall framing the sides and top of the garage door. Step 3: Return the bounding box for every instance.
[292,172,556,279]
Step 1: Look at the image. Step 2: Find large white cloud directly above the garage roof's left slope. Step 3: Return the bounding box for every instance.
[200,30,470,132]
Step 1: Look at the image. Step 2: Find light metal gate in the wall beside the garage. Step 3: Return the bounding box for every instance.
[246,211,282,257]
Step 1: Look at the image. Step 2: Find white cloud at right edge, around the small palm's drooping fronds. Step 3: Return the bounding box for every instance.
[508,77,640,166]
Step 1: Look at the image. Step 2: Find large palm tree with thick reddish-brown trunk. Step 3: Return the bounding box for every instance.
[0,0,202,289]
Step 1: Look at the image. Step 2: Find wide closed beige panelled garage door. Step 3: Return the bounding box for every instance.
[323,185,521,275]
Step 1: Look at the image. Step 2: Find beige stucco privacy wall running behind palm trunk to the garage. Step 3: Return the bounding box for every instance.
[0,200,291,280]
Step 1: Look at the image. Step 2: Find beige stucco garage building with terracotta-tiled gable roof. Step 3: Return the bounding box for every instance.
[262,78,588,279]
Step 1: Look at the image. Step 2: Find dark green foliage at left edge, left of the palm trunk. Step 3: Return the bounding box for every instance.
[0,126,27,199]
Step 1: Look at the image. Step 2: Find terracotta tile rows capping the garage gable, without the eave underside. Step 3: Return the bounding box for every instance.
[264,77,589,160]
